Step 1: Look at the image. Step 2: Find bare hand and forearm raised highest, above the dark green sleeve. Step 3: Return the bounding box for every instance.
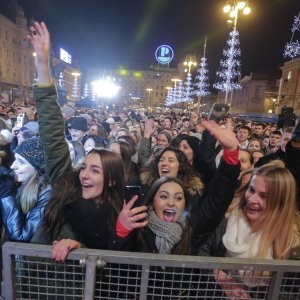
[27,22,51,84]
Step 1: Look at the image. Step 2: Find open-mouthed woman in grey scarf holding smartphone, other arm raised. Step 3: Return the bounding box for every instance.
[115,121,239,255]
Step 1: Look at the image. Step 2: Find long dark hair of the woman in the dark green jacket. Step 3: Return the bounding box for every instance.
[42,149,125,240]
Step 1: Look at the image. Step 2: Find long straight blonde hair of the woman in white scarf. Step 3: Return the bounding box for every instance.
[241,161,300,259]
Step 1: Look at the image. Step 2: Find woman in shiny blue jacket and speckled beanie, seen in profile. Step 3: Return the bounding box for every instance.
[0,137,51,241]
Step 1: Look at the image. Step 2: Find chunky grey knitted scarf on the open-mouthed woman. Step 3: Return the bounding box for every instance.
[148,206,186,254]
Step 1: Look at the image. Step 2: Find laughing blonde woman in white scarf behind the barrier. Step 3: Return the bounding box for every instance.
[198,161,300,299]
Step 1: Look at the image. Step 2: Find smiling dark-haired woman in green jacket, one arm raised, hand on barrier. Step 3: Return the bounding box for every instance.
[29,22,125,261]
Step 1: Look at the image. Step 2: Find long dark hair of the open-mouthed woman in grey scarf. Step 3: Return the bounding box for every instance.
[140,176,192,255]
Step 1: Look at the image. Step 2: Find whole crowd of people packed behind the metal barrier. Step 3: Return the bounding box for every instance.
[0,22,300,297]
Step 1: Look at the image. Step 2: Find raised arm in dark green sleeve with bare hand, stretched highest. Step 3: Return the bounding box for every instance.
[28,22,71,183]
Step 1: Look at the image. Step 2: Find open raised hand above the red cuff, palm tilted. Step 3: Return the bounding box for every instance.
[202,119,239,151]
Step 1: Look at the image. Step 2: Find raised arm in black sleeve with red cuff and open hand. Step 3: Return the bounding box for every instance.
[192,121,240,251]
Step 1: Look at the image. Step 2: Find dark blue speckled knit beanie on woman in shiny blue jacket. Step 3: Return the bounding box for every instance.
[15,137,45,175]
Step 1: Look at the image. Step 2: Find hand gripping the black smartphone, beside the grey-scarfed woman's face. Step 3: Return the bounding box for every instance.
[118,196,148,231]
